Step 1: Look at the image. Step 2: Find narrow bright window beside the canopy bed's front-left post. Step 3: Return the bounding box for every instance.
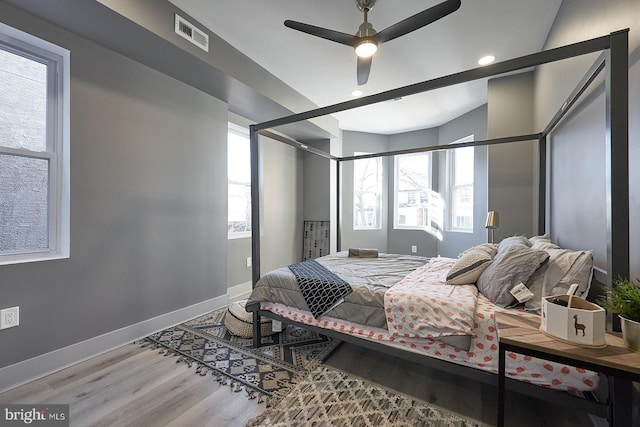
[227,123,251,239]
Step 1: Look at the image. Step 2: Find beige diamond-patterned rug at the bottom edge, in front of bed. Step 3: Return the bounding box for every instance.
[247,366,483,427]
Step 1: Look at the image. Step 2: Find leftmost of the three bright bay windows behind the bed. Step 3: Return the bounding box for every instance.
[353,152,382,230]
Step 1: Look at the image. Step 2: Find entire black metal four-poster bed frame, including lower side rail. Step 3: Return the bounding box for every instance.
[250,29,631,418]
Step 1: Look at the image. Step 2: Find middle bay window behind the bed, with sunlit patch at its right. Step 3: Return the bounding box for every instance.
[394,153,443,237]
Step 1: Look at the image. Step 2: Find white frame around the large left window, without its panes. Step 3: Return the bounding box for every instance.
[0,23,71,265]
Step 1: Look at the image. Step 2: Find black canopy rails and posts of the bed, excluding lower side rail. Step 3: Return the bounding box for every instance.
[250,29,629,338]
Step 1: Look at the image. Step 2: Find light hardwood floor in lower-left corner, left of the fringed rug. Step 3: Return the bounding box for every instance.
[0,344,265,427]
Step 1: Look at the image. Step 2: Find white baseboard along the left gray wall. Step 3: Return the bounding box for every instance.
[0,294,229,393]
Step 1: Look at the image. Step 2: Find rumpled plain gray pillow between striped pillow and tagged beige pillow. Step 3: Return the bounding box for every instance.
[476,242,549,307]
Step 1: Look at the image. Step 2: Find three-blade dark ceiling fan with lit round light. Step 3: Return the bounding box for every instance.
[284,0,460,85]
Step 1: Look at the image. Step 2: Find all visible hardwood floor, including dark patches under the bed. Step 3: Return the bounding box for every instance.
[0,343,608,427]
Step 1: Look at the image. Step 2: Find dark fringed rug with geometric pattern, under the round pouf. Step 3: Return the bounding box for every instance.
[143,308,339,406]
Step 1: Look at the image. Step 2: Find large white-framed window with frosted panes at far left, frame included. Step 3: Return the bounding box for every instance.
[0,24,70,264]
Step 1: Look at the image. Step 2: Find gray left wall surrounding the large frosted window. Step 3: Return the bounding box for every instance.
[0,3,227,367]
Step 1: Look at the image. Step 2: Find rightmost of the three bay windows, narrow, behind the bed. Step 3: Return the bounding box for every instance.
[447,135,474,232]
